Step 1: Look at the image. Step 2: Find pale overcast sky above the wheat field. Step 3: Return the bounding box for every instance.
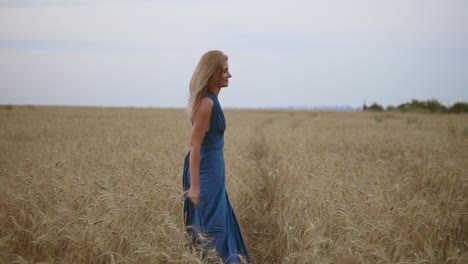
[0,0,468,108]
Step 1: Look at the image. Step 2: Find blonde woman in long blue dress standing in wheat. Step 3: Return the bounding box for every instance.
[183,50,250,263]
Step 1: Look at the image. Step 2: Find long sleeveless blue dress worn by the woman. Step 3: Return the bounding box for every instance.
[182,91,250,263]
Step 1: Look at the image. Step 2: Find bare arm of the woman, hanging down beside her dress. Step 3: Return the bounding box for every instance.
[187,97,213,206]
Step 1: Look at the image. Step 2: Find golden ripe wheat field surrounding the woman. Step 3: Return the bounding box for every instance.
[0,106,468,263]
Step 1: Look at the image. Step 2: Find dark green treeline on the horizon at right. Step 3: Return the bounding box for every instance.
[363,99,468,114]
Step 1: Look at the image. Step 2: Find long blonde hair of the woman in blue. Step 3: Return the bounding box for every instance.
[187,50,228,120]
